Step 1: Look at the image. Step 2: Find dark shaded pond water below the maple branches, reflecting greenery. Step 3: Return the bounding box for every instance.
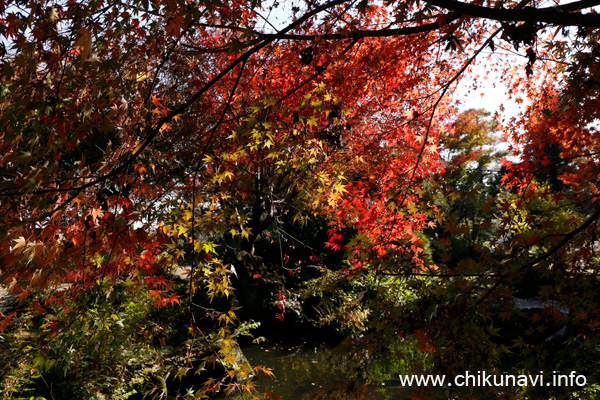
[242,343,409,400]
